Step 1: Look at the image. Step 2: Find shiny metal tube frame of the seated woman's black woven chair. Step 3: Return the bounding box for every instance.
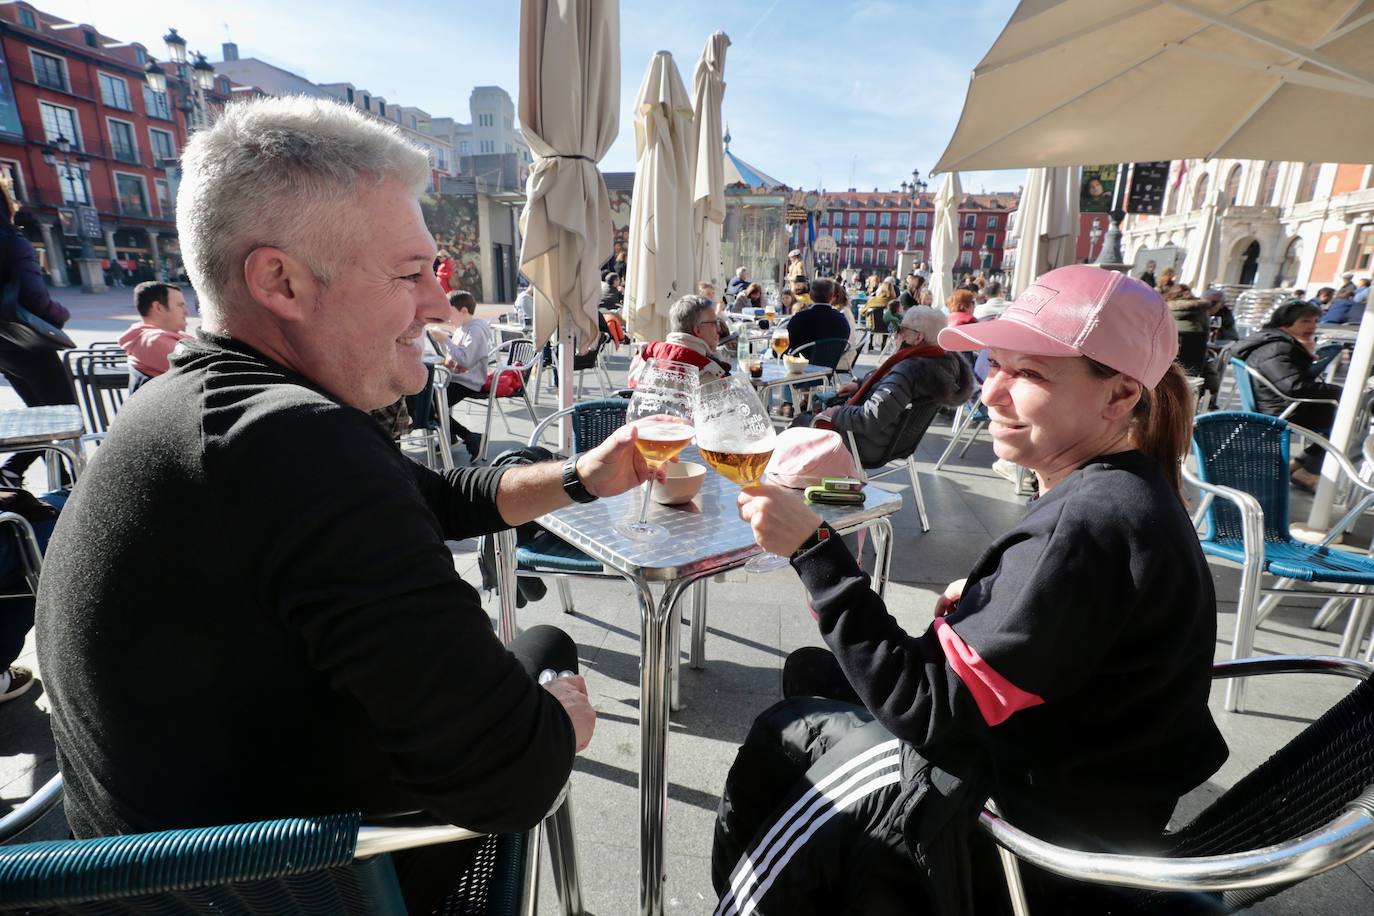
[978,655,1374,916]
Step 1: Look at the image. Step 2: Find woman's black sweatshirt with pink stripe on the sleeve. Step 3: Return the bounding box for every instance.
[794,452,1227,847]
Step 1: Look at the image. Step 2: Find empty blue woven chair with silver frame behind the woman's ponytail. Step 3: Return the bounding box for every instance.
[1183,411,1374,711]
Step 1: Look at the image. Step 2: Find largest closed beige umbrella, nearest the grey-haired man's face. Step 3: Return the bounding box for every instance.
[519,0,620,351]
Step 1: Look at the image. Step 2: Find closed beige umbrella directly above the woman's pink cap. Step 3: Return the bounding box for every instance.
[1010,166,1079,298]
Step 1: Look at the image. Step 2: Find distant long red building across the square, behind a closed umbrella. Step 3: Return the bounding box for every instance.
[793,190,1017,273]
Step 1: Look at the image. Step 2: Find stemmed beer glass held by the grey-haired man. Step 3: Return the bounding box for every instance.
[616,360,697,541]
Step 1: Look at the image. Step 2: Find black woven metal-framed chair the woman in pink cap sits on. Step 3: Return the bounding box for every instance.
[978,655,1374,916]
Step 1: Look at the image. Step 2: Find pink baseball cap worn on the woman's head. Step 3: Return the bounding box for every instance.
[940,264,1179,389]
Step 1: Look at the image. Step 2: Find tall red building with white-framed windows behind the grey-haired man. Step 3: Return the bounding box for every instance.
[0,3,243,286]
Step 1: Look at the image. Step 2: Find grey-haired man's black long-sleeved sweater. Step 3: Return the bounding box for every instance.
[37,338,573,836]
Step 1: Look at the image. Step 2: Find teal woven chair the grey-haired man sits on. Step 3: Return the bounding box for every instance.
[0,776,583,916]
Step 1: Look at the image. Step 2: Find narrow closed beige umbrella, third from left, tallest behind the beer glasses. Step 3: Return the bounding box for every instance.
[691,32,730,295]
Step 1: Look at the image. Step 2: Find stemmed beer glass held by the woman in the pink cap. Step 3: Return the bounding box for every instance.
[692,376,787,573]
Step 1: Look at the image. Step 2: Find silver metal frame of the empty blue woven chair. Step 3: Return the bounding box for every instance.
[1183,413,1374,713]
